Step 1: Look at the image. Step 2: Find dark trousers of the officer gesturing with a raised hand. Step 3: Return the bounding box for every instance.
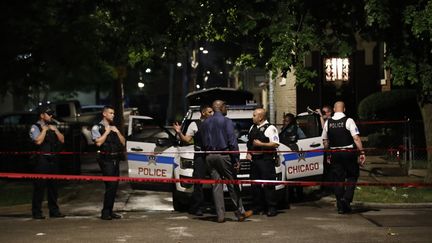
[190,154,207,212]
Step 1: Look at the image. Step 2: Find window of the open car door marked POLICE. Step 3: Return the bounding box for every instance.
[129,119,169,143]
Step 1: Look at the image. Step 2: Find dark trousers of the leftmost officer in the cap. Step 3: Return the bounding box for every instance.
[32,155,59,216]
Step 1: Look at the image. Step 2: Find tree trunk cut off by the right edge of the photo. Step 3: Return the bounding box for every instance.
[420,103,432,183]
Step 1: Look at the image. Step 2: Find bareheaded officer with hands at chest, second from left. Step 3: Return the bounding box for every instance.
[92,106,126,220]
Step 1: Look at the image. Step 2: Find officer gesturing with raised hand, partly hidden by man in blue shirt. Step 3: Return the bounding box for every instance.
[173,105,213,216]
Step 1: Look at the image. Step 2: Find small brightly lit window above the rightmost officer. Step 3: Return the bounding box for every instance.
[324,58,349,81]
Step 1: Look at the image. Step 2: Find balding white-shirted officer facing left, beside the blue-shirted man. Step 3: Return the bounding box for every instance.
[247,108,279,217]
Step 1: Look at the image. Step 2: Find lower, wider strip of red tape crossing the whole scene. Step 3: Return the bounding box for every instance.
[0,173,432,188]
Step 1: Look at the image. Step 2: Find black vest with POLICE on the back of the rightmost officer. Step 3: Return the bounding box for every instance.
[327,117,354,148]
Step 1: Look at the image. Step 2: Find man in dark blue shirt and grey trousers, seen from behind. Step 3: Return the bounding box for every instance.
[201,100,253,223]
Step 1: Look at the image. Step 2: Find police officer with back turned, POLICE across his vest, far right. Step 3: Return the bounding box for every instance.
[322,101,366,214]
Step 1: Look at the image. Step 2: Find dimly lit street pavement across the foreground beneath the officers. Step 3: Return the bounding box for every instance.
[0,181,432,242]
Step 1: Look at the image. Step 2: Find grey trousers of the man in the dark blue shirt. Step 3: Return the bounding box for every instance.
[206,154,245,219]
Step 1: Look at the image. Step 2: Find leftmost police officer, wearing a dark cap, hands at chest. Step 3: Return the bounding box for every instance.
[30,106,65,219]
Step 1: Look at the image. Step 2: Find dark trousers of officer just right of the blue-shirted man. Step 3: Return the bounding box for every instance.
[251,156,277,210]
